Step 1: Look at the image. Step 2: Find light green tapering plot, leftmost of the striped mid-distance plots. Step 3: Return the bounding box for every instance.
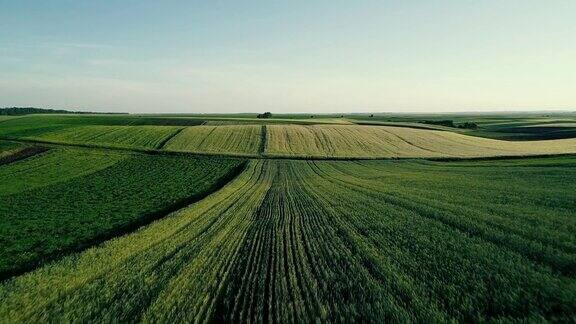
[28,126,181,149]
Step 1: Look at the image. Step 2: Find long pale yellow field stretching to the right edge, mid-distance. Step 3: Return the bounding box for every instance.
[265,125,576,158]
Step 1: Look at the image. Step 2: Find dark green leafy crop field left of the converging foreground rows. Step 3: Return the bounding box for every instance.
[0,156,246,280]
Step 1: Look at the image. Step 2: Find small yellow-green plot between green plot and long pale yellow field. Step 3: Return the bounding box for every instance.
[164,125,262,155]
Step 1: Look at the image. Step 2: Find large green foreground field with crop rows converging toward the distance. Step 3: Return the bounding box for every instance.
[0,157,576,322]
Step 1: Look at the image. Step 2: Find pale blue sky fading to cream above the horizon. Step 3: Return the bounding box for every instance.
[0,0,576,113]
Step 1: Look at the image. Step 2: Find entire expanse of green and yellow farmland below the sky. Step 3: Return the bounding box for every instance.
[0,114,576,323]
